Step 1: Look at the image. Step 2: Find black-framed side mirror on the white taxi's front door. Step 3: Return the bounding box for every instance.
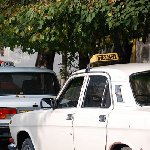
[40,98,55,109]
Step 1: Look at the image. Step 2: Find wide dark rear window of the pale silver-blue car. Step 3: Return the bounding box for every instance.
[0,72,59,96]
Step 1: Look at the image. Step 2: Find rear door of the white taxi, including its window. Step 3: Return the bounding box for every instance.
[73,73,113,150]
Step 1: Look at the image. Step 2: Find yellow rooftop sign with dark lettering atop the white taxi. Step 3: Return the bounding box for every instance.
[90,53,119,66]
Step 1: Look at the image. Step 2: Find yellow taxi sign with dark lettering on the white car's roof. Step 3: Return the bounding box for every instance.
[90,53,119,64]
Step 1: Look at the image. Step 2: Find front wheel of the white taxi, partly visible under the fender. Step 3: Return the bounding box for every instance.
[21,138,35,150]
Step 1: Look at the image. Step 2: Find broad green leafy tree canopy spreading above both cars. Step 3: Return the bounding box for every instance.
[0,0,150,78]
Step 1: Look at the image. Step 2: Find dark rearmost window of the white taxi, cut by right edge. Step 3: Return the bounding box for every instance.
[130,71,150,106]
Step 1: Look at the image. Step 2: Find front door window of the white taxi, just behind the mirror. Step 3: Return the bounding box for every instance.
[57,77,84,108]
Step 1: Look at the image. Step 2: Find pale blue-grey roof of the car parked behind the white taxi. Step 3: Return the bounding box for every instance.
[0,66,55,74]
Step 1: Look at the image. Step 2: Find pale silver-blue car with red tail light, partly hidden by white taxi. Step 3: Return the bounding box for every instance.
[0,66,60,141]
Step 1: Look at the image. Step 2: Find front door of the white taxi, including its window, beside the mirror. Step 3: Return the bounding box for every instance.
[41,75,88,150]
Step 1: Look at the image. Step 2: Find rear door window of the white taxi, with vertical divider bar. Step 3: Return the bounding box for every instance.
[83,75,111,108]
